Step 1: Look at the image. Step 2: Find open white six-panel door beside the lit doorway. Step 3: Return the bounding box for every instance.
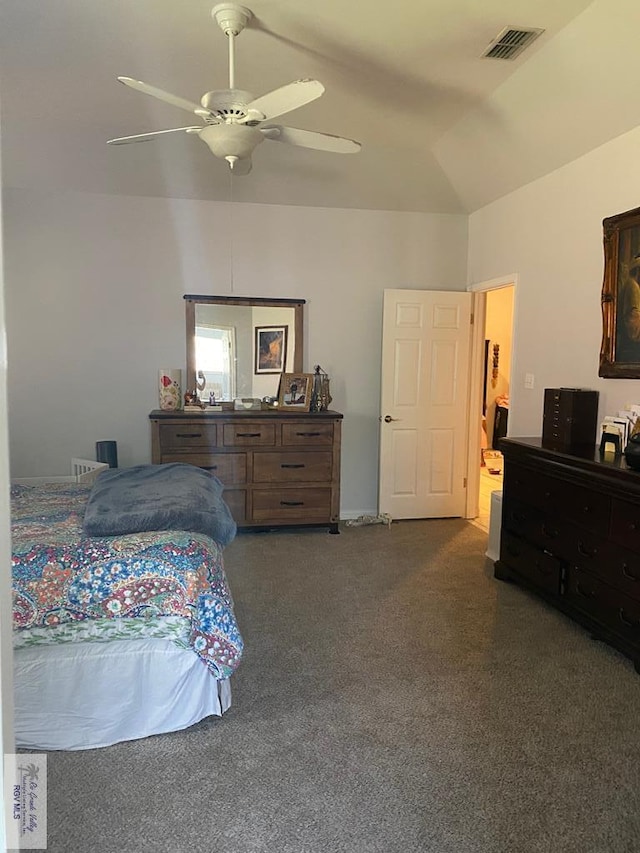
[379,290,471,518]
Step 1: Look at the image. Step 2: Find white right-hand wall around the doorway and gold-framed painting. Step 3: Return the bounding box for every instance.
[469,127,640,436]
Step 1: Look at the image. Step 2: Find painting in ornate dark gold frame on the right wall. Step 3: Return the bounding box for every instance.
[598,207,640,379]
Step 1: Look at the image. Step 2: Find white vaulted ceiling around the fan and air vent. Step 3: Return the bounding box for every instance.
[0,0,640,213]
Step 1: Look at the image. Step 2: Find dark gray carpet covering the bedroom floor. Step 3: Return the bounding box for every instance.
[40,520,640,853]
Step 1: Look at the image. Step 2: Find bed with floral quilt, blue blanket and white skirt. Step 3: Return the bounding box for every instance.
[11,465,243,750]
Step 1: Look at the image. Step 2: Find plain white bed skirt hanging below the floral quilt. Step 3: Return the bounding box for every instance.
[14,637,231,750]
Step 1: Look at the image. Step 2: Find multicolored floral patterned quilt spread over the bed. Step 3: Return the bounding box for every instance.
[11,483,243,678]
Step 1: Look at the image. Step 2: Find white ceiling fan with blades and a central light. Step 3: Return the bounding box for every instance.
[108,3,360,175]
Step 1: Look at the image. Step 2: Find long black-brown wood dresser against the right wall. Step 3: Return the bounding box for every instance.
[495,438,640,672]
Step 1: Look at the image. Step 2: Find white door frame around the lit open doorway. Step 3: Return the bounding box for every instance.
[465,273,518,518]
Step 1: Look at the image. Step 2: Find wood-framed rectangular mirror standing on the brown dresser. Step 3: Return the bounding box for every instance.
[184,294,305,401]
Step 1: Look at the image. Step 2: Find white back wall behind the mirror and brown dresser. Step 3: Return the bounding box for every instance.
[4,189,467,515]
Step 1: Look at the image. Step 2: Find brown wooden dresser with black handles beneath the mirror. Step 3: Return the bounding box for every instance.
[149,410,342,533]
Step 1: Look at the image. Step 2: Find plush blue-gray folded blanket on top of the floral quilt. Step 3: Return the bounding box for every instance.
[84,462,236,547]
